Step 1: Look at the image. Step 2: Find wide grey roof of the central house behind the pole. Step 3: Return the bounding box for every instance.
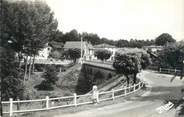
[64,41,93,49]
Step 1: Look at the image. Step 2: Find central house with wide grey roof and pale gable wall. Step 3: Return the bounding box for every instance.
[64,41,94,60]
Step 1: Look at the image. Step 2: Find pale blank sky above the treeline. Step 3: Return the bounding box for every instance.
[45,0,184,41]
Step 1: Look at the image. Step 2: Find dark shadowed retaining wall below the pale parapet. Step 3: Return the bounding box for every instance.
[76,64,116,94]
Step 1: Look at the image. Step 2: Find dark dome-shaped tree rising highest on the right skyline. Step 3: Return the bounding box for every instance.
[155,33,176,46]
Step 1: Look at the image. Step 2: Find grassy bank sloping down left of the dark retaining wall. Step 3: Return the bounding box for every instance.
[22,65,80,99]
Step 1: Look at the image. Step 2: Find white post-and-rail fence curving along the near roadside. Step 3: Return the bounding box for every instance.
[2,82,144,117]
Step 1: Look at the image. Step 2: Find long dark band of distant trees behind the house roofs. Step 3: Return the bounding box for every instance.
[51,29,155,48]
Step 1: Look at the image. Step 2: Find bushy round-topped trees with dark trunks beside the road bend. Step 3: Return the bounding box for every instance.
[113,52,151,85]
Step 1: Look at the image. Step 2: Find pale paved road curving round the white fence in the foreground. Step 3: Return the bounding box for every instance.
[54,71,184,117]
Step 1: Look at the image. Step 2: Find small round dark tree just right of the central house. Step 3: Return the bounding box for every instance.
[95,49,112,61]
